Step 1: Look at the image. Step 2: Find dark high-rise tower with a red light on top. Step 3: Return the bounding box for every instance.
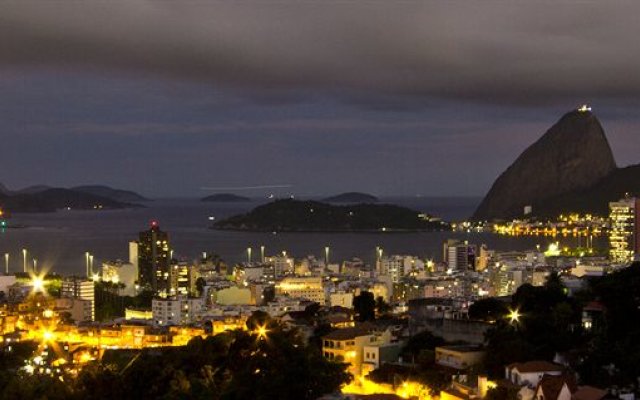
[138,221,171,296]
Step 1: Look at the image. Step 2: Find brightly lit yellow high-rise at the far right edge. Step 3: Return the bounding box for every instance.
[609,198,640,264]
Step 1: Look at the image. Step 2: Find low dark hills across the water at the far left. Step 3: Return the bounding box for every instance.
[0,184,147,214]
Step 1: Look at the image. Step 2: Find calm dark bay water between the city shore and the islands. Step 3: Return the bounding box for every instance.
[0,198,604,274]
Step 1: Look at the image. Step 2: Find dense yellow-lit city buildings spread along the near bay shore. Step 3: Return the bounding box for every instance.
[0,216,636,398]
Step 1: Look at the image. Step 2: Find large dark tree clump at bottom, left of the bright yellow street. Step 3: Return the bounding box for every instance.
[67,313,351,400]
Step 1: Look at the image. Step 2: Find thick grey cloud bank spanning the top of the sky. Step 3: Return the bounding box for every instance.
[0,0,640,107]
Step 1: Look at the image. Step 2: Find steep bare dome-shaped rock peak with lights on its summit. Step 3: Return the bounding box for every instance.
[473,107,617,220]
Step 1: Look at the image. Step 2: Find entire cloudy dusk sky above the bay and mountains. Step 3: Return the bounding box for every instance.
[0,0,640,197]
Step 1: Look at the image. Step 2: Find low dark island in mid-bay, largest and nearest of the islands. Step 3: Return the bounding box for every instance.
[213,199,450,232]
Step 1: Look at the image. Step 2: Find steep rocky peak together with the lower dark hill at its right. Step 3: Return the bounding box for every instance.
[473,108,640,220]
